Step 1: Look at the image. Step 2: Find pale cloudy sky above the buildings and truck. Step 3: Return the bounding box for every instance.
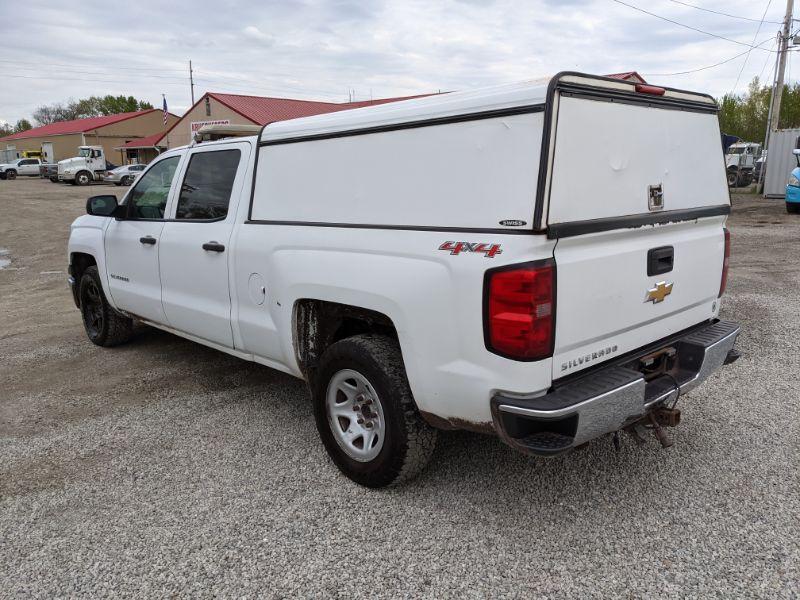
[0,0,800,124]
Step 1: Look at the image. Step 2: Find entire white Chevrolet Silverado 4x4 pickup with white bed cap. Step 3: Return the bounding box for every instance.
[69,73,739,487]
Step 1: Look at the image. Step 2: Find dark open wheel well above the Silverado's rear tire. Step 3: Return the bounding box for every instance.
[294,299,398,382]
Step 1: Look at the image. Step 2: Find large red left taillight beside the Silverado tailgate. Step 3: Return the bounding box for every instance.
[483,258,556,361]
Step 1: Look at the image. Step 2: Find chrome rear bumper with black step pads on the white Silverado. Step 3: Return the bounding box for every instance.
[492,321,739,455]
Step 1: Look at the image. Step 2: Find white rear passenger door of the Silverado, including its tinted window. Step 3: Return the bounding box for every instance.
[159,142,251,348]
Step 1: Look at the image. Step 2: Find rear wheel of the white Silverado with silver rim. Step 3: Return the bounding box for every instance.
[313,334,437,488]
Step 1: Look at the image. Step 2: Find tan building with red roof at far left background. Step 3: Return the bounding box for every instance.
[0,108,180,162]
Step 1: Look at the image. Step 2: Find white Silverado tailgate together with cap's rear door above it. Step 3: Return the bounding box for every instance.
[546,80,730,378]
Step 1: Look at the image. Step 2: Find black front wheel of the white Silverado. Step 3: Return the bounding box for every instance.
[79,266,133,348]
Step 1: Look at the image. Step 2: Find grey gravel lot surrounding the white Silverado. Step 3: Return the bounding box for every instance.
[0,179,800,598]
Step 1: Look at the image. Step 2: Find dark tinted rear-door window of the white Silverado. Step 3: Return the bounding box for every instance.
[175,150,242,221]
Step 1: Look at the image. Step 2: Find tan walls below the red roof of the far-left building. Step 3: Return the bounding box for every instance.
[0,110,180,165]
